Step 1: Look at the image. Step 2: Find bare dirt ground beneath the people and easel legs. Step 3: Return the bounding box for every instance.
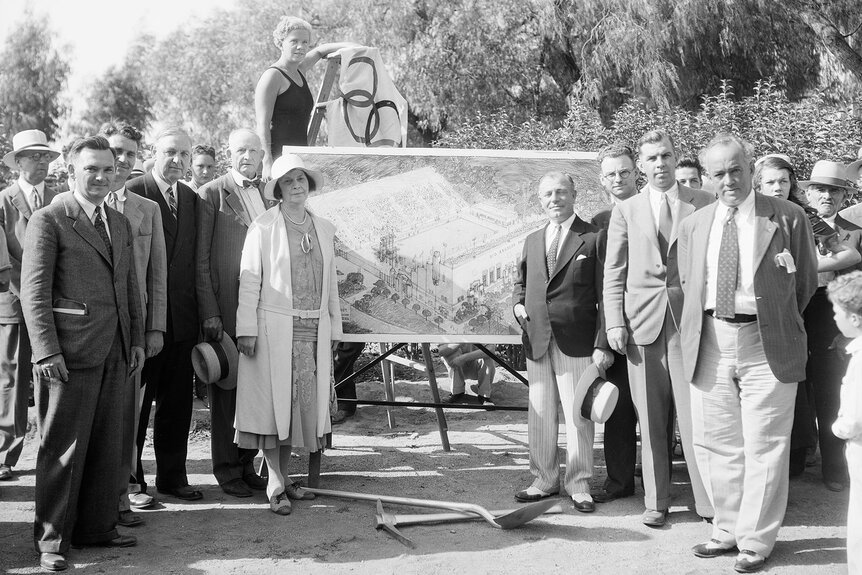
[0,362,848,575]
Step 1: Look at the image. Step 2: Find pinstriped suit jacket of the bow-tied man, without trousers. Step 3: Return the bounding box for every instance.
[195,173,276,337]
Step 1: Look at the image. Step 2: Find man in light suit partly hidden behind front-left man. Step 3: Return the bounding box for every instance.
[102,124,168,527]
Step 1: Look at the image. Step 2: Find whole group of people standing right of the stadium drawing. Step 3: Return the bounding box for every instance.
[513,131,862,573]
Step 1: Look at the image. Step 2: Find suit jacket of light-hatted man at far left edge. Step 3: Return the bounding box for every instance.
[0,182,56,323]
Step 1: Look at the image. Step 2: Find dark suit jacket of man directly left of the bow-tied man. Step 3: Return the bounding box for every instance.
[126,172,199,345]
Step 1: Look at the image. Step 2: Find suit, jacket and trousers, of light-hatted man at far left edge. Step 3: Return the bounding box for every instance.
[0,182,54,467]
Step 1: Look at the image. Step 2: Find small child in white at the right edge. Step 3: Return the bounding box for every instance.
[829,271,862,575]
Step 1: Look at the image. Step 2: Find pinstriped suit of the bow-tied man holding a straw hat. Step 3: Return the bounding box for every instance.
[195,172,275,485]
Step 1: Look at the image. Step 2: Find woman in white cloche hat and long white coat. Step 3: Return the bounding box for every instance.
[236,154,342,515]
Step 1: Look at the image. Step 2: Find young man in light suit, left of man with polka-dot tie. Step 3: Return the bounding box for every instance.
[604,131,715,527]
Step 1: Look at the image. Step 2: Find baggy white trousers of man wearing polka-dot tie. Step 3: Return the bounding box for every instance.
[691,315,797,557]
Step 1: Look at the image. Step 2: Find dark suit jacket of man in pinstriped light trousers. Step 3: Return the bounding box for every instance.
[512,217,608,360]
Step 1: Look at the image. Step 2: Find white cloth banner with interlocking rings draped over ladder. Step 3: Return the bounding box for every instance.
[326,46,407,148]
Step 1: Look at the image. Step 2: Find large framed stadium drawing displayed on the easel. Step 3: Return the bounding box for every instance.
[285,147,609,343]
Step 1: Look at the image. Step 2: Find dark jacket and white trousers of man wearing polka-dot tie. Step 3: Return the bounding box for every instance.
[679,192,817,557]
